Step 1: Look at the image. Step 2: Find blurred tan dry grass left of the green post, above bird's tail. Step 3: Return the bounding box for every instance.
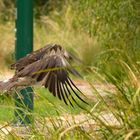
[0,23,15,72]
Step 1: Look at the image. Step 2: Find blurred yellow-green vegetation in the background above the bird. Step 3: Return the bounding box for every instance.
[0,0,140,72]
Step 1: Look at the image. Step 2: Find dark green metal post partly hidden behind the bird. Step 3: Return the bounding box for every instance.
[15,0,33,124]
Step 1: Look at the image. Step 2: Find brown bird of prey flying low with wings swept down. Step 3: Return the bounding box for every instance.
[0,44,86,106]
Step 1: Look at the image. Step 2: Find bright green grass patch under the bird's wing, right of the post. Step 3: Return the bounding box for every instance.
[35,88,89,116]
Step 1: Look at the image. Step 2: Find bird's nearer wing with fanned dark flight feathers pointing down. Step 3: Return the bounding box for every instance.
[15,55,86,106]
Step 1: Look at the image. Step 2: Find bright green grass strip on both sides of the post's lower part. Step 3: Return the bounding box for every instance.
[0,88,90,122]
